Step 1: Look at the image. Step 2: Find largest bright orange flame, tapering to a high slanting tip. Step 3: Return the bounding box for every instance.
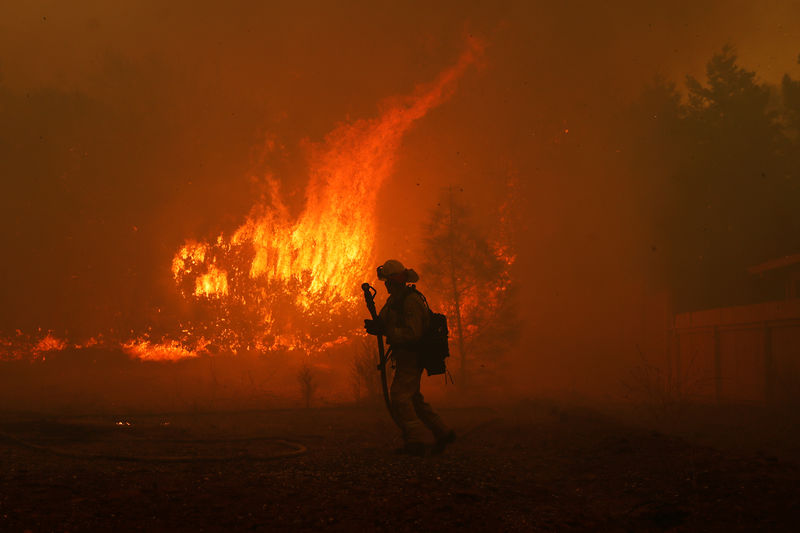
[172,41,481,352]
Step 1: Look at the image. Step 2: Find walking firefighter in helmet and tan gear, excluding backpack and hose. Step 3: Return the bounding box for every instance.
[365,259,455,456]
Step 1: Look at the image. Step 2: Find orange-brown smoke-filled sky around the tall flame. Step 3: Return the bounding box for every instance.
[0,0,800,387]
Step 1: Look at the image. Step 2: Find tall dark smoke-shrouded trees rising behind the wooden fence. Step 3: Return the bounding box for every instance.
[629,46,800,310]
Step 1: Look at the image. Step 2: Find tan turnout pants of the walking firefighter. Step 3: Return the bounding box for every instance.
[390,348,448,443]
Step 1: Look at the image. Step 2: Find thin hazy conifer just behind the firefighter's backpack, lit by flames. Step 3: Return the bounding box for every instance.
[423,187,519,387]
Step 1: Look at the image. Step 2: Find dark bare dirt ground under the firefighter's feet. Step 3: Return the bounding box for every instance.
[0,401,800,532]
